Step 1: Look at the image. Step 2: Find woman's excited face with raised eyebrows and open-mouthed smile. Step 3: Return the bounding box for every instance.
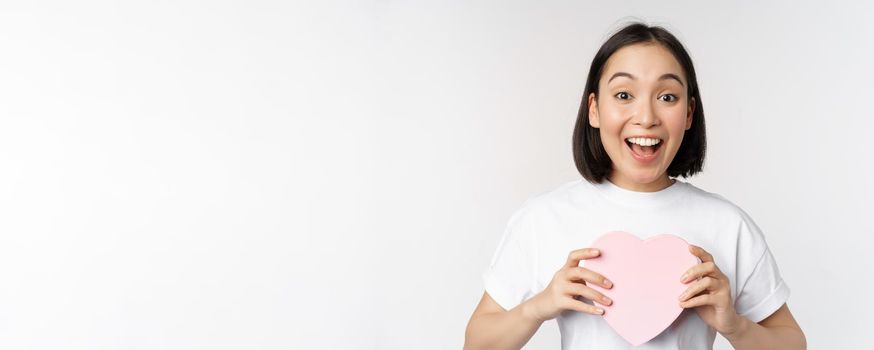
[588,43,695,192]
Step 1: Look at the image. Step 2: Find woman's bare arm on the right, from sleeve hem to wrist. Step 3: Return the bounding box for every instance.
[723,304,807,350]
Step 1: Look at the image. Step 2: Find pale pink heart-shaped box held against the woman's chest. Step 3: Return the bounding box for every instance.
[584,231,700,346]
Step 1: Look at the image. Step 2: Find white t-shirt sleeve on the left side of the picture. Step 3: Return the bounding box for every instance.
[482,208,536,310]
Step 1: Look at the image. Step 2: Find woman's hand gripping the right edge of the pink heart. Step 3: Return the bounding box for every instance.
[680,245,742,336]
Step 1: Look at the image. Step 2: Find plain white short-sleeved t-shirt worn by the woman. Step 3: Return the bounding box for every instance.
[483,179,789,350]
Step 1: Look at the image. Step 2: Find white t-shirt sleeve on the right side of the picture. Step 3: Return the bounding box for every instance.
[734,213,789,323]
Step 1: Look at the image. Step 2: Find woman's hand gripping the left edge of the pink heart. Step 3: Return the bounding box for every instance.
[528,248,613,322]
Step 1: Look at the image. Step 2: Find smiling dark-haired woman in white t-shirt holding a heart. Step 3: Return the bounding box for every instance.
[465,23,806,349]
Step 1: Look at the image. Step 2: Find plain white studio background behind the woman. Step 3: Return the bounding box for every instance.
[0,0,874,349]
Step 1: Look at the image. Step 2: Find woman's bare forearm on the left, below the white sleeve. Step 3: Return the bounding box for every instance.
[464,301,543,350]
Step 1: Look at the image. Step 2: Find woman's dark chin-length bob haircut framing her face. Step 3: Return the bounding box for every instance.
[573,22,707,183]
